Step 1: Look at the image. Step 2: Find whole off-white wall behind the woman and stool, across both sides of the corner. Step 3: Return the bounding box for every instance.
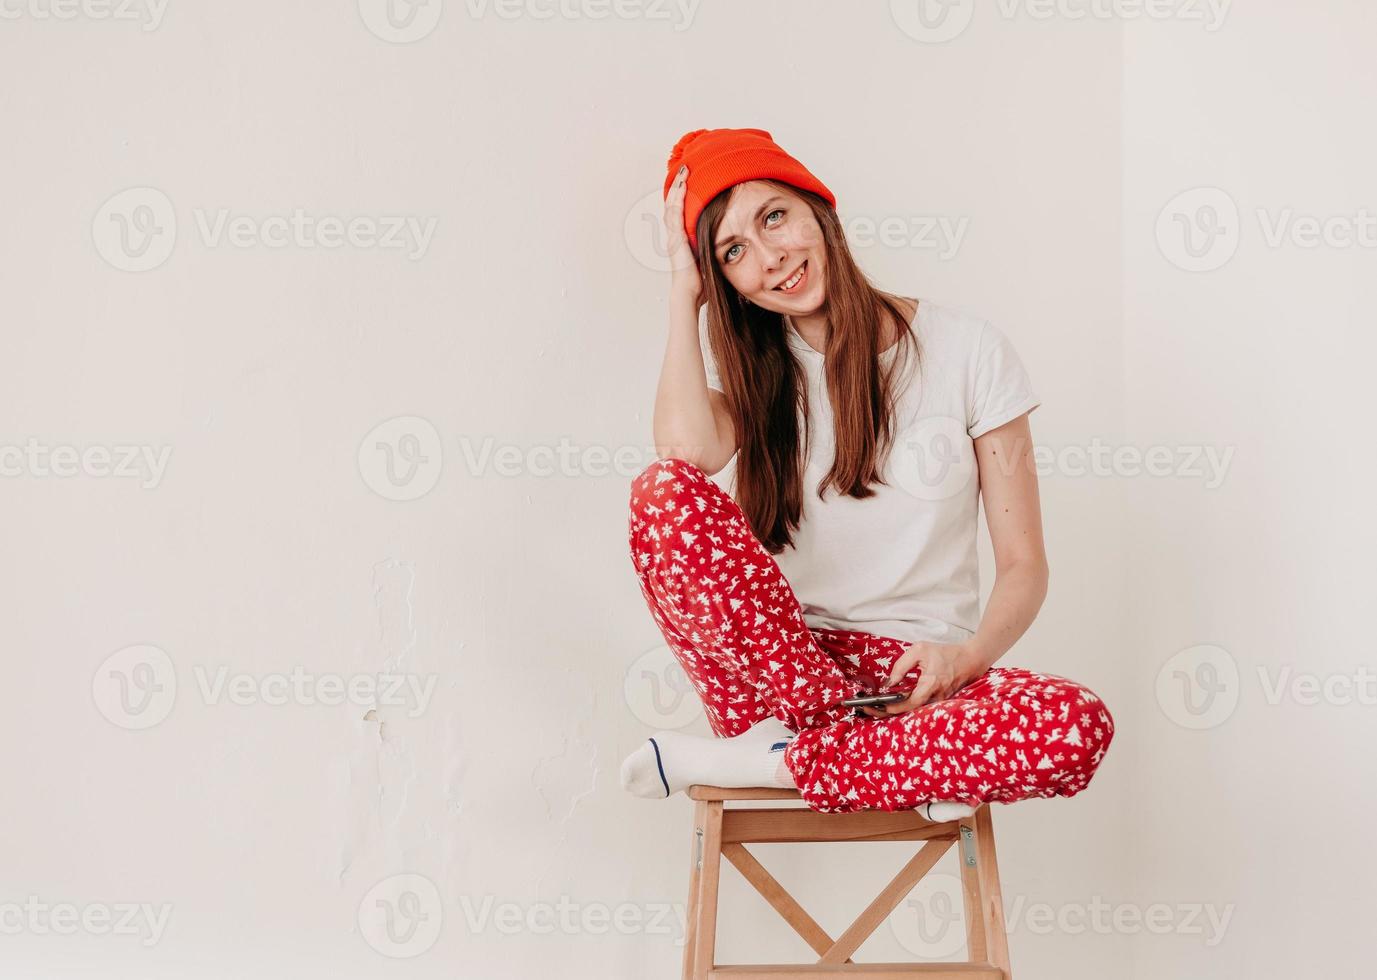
[0,0,1354,980]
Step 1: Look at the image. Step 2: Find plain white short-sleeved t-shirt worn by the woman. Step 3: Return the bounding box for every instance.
[700,297,1041,643]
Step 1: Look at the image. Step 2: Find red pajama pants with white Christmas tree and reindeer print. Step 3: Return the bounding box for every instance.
[628,458,1114,812]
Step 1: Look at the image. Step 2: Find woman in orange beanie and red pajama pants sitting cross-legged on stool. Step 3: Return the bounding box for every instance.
[621,129,1114,820]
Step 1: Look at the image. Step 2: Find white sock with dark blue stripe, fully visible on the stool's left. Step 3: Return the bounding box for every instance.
[621,716,796,800]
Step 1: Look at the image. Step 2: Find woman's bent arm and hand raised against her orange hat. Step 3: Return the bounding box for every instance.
[651,168,737,476]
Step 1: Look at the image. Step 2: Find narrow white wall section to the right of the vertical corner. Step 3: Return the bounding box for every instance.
[1118,3,1377,977]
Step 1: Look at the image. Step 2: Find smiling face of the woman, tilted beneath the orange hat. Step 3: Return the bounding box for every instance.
[713,180,826,317]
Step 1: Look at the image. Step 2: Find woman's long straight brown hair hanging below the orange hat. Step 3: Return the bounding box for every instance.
[698,180,920,555]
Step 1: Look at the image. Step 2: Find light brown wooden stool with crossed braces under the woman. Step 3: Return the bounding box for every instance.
[683,786,1012,980]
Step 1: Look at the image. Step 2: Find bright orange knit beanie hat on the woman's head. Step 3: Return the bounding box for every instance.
[664,129,837,252]
